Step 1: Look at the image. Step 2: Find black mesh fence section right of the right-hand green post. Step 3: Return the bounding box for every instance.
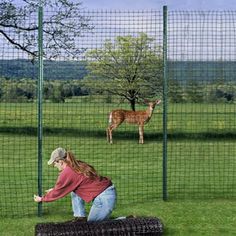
[168,11,236,198]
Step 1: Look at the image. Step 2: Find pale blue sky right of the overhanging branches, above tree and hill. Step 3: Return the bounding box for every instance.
[5,0,236,60]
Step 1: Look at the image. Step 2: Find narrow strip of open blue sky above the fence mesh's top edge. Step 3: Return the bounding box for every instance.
[82,0,236,11]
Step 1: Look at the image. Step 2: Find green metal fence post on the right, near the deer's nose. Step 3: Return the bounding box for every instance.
[163,6,168,200]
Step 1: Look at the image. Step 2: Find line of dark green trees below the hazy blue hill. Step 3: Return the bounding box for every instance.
[0,78,233,103]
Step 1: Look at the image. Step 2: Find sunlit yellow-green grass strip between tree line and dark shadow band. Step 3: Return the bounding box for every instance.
[0,100,236,137]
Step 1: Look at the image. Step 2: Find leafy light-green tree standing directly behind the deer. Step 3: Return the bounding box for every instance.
[84,33,163,110]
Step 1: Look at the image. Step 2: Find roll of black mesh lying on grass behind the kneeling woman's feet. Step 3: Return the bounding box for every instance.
[35,217,163,236]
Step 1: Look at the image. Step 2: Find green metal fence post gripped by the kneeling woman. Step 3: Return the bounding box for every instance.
[38,6,43,216]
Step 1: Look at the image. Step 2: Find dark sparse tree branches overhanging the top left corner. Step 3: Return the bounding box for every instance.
[0,0,91,59]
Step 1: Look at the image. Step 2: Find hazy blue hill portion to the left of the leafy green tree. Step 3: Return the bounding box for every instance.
[0,59,87,80]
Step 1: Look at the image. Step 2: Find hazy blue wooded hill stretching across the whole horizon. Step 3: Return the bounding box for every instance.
[0,59,236,81]
